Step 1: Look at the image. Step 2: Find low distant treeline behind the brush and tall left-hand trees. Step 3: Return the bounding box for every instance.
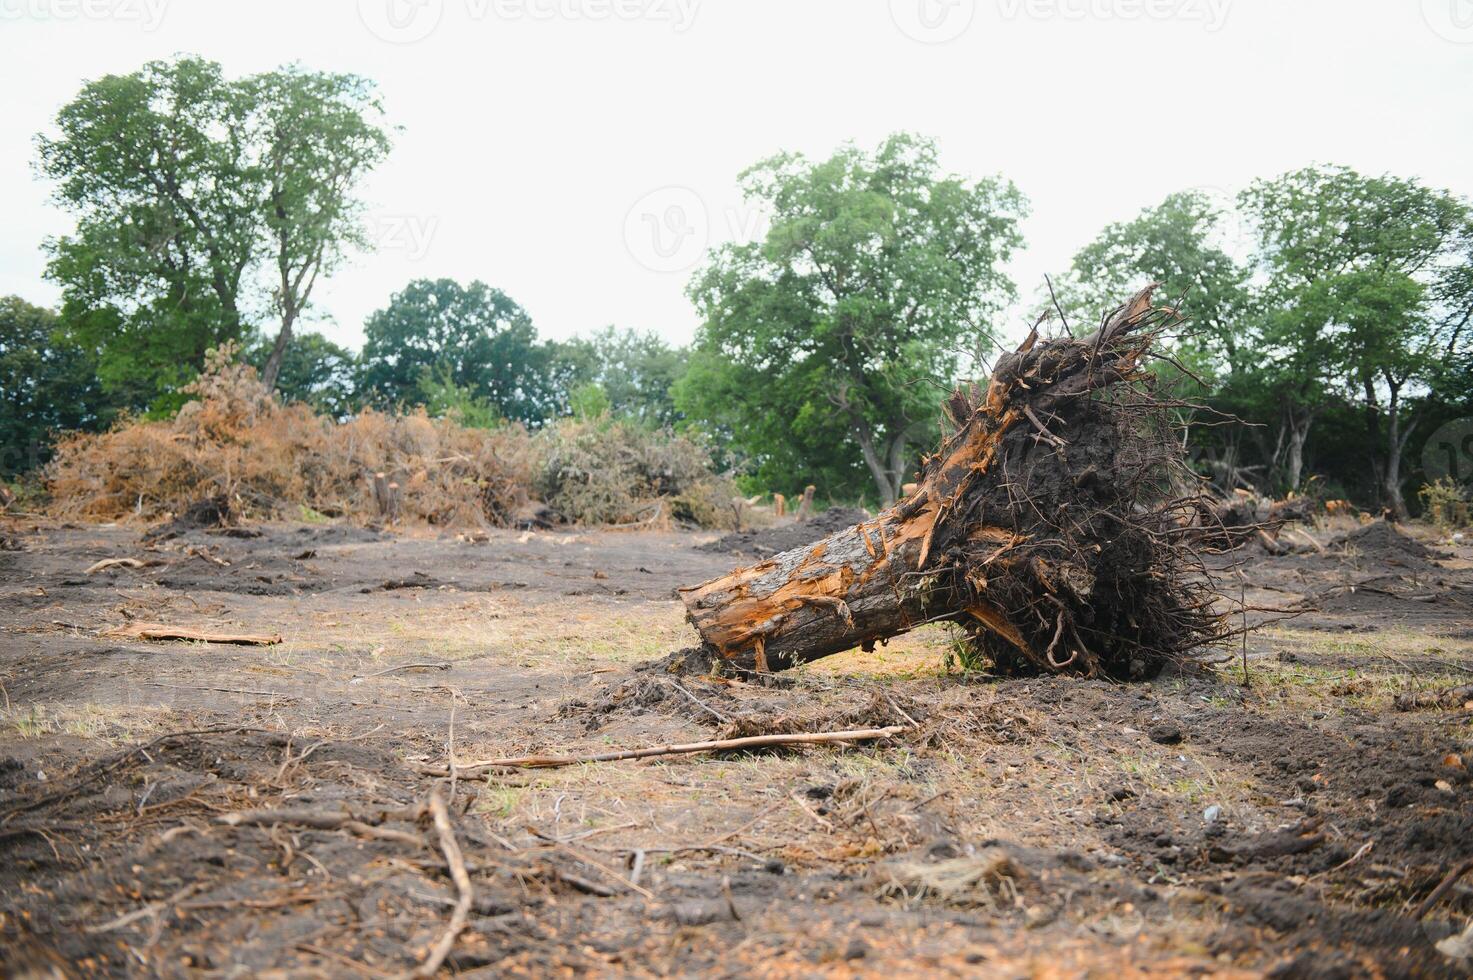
[0,287,688,477]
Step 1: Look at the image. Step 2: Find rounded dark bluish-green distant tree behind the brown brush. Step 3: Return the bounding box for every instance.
[361,279,569,424]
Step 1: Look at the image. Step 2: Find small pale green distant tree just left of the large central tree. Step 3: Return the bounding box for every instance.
[558,326,689,426]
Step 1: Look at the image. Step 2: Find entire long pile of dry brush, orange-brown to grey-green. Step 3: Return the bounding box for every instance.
[46,346,737,528]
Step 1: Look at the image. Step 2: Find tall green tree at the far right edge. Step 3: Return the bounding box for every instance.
[1242,167,1473,516]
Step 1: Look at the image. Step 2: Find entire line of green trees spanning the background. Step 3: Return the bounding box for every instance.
[0,59,1473,511]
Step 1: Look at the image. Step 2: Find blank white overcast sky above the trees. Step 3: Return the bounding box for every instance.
[0,0,1473,346]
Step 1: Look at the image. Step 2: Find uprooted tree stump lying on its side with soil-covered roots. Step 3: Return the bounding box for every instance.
[681,286,1230,679]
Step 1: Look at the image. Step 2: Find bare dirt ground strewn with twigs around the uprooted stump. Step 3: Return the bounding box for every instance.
[0,515,1473,977]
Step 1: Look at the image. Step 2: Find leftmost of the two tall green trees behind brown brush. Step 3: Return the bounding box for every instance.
[38,59,259,407]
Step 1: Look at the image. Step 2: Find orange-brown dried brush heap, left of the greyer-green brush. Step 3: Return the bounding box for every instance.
[47,346,535,526]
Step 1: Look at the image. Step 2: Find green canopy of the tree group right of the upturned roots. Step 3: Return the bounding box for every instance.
[1065,167,1473,513]
